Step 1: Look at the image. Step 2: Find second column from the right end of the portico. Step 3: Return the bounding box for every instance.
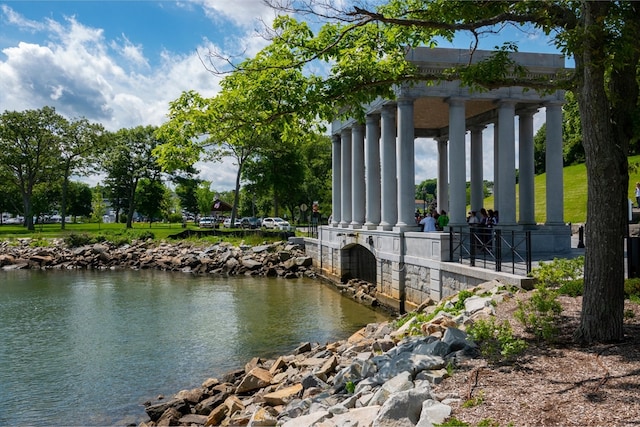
[518,109,536,225]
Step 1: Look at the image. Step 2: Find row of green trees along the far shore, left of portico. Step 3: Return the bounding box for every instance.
[0,107,331,230]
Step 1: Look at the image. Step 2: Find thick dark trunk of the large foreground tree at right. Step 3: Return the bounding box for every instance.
[574,2,629,343]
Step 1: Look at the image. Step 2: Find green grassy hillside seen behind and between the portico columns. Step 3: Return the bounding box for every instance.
[484,156,640,224]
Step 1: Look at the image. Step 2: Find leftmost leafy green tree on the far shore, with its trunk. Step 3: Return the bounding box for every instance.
[0,107,66,230]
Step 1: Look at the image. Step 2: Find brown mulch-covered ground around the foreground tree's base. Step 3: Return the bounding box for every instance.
[434,293,640,427]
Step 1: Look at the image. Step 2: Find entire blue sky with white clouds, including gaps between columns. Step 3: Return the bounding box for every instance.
[0,0,554,191]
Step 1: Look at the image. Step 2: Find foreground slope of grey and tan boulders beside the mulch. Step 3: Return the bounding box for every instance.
[141,282,506,427]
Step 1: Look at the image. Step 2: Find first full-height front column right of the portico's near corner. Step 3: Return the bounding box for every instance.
[449,98,467,226]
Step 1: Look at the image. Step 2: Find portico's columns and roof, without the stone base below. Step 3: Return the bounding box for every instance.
[331,48,564,231]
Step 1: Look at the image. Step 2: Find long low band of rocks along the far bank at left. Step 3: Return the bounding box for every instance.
[0,239,314,278]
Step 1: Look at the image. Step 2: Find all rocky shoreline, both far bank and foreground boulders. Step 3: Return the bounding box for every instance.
[0,239,507,427]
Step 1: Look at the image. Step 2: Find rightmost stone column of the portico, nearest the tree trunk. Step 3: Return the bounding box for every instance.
[545,102,564,225]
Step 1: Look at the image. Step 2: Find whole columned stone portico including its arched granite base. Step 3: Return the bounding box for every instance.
[308,48,571,314]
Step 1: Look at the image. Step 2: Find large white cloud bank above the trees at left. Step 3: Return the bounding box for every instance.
[0,6,240,190]
